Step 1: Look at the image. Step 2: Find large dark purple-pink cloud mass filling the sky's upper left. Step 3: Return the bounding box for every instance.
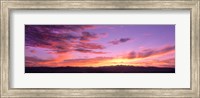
[25,25,105,53]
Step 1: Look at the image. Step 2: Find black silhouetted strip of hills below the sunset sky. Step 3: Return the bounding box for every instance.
[25,65,175,73]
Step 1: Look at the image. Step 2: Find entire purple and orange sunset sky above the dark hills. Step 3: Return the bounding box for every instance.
[25,25,175,68]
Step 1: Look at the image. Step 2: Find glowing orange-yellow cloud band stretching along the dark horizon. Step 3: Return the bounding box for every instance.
[26,55,175,67]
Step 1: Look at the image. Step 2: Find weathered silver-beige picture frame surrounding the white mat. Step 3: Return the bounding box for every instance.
[0,0,200,98]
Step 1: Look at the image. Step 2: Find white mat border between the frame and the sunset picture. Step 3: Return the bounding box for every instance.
[10,10,190,88]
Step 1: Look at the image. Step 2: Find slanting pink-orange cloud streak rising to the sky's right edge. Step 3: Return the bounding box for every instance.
[126,45,175,59]
